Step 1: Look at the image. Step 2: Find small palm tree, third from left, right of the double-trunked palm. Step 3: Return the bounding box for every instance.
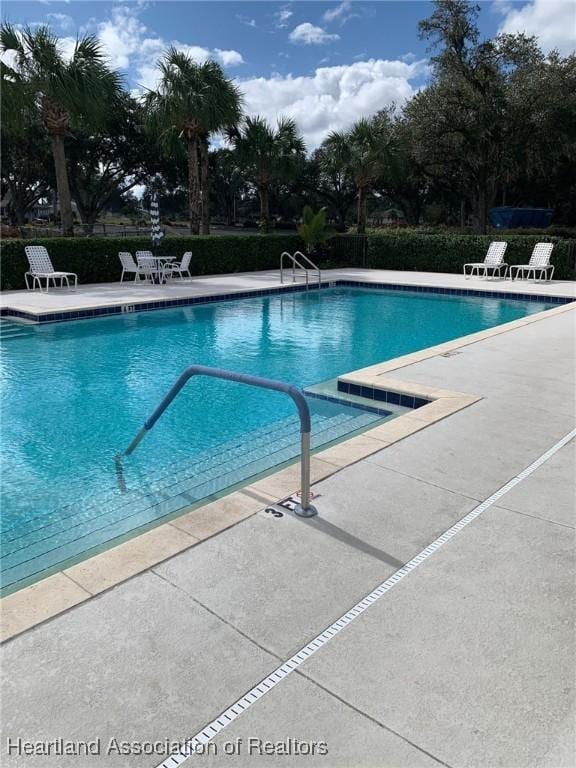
[228,116,306,232]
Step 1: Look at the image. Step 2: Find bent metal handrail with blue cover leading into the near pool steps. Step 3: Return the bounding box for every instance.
[116,365,317,517]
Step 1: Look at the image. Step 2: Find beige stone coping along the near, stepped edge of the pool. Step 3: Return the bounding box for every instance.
[0,294,576,642]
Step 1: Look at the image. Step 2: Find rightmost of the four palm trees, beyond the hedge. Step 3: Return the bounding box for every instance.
[322,112,391,235]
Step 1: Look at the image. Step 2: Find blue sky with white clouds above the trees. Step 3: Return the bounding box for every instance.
[2,0,576,150]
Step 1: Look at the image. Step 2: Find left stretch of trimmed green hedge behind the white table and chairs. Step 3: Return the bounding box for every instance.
[0,234,303,290]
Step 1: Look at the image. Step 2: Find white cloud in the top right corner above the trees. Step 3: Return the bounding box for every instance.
[498,0,576,55]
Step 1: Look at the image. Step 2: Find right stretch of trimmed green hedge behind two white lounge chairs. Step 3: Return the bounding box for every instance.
[366,233,576,280]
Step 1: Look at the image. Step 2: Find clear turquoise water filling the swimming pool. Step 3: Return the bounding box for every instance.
[1,288,547,588]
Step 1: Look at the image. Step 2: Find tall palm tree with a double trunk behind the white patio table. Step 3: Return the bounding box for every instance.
[146,47,242,235]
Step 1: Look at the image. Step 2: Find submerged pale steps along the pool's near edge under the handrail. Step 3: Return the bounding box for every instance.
[2,401,388,587]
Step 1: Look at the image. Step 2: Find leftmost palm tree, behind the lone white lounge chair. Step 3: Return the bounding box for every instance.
[0,23,121,236]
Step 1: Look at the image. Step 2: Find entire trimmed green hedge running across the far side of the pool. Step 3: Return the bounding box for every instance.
[0,230,576,290]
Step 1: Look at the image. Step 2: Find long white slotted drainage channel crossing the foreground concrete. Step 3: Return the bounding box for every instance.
[156,429,576,768]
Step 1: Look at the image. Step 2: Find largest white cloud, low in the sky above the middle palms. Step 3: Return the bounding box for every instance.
[238,59,427,149]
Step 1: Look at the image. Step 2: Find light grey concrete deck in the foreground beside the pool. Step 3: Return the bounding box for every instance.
[2,273,576,768]
